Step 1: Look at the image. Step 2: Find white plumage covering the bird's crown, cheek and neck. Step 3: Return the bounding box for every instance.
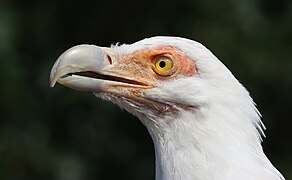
[99,37,284,180]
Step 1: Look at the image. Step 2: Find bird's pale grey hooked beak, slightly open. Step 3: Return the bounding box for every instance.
[49,45,148,92]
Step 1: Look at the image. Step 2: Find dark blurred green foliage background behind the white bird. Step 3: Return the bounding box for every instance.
[0,0,292,180]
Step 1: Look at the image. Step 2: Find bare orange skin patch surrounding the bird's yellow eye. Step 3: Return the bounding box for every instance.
[109,46,197,86]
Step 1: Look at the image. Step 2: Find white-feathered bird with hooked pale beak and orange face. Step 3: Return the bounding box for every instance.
[49,36,285,180]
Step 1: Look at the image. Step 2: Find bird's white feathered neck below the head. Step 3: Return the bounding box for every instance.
[144,105,281,180]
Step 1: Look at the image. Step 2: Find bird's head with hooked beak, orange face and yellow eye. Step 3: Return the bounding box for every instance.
[50,36,260,134]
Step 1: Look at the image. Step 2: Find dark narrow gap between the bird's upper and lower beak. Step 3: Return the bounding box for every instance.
[61,71,149,87]
